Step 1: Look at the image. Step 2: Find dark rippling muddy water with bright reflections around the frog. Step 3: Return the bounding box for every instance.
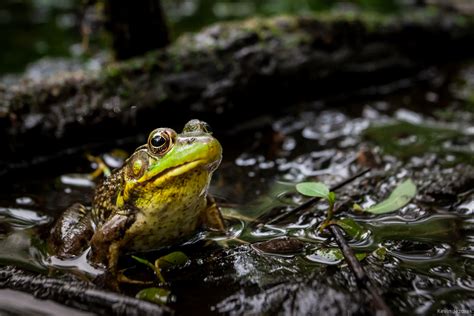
[0,66,474,315]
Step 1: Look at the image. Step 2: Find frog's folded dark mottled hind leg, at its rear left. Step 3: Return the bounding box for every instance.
[48,203,94,258]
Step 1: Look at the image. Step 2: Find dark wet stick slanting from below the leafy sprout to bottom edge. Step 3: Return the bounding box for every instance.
[328,224,393,316]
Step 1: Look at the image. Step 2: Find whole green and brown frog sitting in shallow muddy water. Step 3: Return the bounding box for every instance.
[50,120,225,274]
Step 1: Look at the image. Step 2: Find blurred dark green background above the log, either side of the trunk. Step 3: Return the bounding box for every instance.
[0,0,474,74]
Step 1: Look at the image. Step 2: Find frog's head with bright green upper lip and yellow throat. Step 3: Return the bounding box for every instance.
[116,120,222,207]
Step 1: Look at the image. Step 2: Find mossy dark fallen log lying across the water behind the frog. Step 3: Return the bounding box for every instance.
[0,11,474,161]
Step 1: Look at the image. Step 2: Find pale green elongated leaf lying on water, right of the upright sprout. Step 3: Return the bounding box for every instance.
[365,179,416,214]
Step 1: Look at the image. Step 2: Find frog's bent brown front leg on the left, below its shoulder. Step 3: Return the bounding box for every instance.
[89,212,135,276]
